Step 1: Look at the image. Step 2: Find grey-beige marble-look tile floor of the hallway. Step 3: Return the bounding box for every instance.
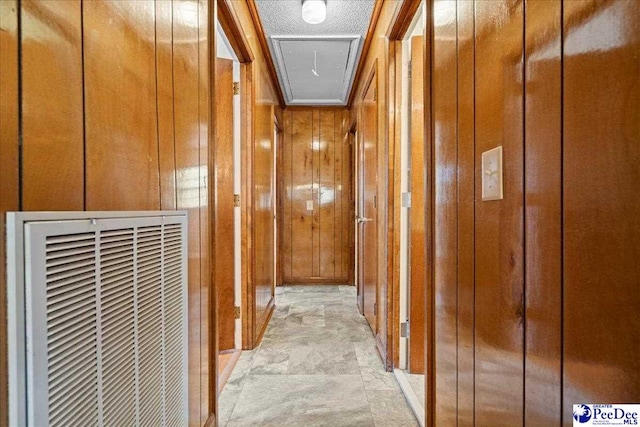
[219,285,418,427]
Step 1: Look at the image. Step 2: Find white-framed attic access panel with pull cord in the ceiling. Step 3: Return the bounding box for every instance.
[271,35,361,105]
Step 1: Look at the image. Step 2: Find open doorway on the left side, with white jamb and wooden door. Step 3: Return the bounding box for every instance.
[213,18,242,393]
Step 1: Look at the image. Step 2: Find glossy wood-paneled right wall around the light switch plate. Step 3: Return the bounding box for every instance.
[427,0,640,425]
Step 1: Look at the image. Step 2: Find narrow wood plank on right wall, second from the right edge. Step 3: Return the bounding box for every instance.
[524,0,562,425]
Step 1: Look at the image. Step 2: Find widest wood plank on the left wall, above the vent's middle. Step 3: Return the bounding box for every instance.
[83,1,160,210]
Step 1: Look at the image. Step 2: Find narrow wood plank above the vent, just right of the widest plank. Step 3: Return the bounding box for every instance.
[156,0,177,210]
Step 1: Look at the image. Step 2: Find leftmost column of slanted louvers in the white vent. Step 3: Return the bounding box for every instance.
[46,233,98,426]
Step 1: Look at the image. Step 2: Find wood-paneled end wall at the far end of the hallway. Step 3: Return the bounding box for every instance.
[280,108,353,283]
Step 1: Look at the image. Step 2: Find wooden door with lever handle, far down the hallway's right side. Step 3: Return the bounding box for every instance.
[358,71,378,334]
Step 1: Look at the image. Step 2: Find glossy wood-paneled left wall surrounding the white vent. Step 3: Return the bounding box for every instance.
[0,0,214,425]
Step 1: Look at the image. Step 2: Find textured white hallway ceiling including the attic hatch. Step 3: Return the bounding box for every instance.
[255,0,375,105]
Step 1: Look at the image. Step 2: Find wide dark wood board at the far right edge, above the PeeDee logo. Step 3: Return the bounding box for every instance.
[562,1,640,425]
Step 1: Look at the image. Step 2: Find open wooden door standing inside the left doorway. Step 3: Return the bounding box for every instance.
[214,58,235,351]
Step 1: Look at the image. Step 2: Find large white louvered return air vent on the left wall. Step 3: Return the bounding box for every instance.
[7,211,188,427]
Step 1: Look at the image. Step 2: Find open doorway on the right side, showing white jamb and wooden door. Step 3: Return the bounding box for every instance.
[396,1,427,425]
